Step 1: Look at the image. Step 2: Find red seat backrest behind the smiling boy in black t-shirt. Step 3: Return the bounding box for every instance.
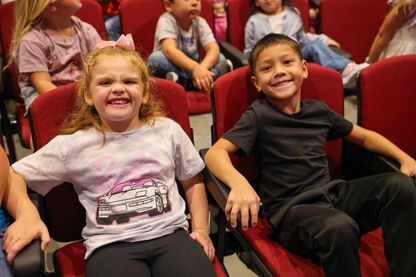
[211,63,344,192]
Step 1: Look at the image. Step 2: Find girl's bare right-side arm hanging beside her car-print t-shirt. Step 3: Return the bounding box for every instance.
[180,174,215,261]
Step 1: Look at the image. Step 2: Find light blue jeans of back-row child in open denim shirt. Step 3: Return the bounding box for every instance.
[302,40,352,74]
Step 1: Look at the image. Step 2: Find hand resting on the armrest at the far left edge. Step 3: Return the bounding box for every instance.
[3,217,50,264]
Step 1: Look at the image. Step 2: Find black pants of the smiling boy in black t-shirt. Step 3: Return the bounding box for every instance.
[272,173,416,277]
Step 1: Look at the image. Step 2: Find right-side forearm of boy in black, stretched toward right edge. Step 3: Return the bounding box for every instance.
[345,124,416,177]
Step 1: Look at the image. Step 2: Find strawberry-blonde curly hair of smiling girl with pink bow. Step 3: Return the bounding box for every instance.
[61,46,166,140]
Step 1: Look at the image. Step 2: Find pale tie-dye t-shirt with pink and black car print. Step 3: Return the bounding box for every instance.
[12,118,204,258]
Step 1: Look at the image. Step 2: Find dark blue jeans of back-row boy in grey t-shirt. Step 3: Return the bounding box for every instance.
[147,51,225,90]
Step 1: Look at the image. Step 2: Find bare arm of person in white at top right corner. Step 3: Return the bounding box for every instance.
[368,5,409,62]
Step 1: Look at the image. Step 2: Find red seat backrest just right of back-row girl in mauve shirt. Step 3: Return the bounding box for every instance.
[74,0,107,40]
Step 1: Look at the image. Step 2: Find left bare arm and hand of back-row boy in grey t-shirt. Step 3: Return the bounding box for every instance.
[161,38,214,90]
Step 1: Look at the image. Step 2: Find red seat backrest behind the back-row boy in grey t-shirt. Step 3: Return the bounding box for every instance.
[120,0,214,59]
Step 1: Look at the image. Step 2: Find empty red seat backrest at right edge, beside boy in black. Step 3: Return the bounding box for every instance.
[357,54,416,158]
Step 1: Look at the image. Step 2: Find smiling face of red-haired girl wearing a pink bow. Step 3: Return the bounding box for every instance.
[84,54,148,132]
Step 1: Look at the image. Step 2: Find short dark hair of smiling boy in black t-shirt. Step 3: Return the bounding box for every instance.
[248,33,303,76]
